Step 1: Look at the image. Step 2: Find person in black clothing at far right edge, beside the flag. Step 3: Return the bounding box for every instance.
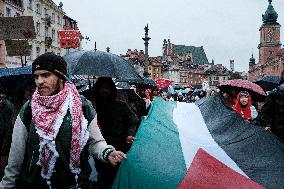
[254,70,284,140]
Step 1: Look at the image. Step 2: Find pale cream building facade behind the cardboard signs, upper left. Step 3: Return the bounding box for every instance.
[24,0,66,64]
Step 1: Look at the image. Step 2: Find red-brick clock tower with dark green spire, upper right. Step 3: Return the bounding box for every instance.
[248,0,284,81]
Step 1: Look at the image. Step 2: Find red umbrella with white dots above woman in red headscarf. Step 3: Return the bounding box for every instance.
[218,79,266,101]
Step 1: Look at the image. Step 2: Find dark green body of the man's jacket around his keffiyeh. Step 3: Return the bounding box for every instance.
[16,97,96,188]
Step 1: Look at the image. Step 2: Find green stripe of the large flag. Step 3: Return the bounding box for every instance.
[113,98,187,189]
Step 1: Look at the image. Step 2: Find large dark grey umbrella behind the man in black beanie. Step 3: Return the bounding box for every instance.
[64,51,142,81]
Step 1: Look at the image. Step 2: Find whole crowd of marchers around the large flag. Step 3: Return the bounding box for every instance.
[0,53,284,189]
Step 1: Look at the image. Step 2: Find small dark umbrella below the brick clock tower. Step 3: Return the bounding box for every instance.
[254,76,281,91]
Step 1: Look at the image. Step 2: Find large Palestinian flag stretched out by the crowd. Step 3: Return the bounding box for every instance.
[113,94,284,189]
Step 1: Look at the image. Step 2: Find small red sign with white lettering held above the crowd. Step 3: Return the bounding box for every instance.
[59,30,81,49]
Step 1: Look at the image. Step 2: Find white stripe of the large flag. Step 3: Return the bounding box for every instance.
[173,102,246,176]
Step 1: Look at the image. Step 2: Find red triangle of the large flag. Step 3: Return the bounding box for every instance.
[177,148,264,189]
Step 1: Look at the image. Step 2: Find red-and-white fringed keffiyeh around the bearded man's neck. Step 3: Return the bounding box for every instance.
[32,82,89,180]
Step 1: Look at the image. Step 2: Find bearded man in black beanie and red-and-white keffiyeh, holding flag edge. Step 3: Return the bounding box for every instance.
[0,53,126,189]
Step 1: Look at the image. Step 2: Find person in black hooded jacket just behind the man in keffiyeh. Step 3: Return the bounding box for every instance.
[94,77,138,188]
